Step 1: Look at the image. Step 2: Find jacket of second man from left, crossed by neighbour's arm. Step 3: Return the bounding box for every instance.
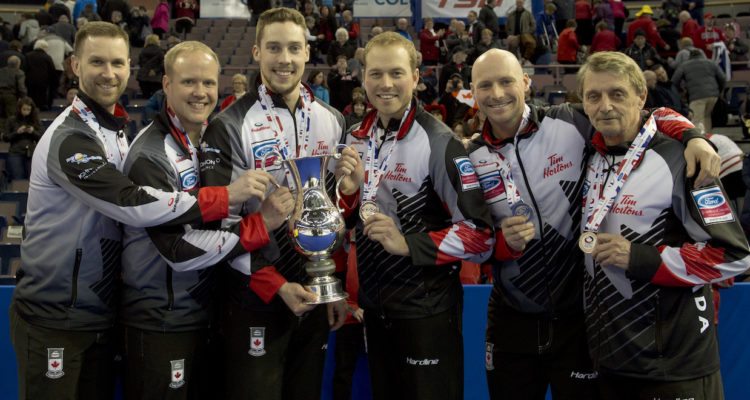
[119,104,268,332]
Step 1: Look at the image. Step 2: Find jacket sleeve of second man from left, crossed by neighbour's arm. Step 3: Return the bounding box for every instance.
[128,156,268,271]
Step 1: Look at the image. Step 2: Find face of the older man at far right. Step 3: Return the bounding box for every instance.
[582,71,647,146]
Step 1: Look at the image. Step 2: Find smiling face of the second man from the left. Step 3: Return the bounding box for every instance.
[162,51,219,139]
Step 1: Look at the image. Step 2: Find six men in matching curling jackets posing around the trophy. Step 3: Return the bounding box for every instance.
[10,8,750,400]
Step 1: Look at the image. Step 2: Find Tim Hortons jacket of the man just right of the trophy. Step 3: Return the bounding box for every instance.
[346,105,500,318]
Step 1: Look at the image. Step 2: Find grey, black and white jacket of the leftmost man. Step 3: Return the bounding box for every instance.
[13,94,228,330]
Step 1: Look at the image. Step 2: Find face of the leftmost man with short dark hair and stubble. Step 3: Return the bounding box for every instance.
[72,36,130,113]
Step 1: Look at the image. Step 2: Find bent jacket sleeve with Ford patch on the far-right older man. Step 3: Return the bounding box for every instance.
[628,177,750,286]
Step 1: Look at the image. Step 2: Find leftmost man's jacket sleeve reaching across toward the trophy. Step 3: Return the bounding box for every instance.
[47,130,229,228]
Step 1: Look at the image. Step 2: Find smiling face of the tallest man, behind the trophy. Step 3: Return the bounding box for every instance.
[253,21,310,100]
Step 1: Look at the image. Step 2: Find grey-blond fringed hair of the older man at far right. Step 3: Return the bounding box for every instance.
[576,51,646,99]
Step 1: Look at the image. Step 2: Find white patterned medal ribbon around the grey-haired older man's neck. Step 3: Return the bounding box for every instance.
[583,115,656,232]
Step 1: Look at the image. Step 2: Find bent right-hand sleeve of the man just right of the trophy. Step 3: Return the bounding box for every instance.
[405,137,494,265]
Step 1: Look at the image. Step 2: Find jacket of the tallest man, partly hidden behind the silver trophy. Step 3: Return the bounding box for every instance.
[200,81,345,309]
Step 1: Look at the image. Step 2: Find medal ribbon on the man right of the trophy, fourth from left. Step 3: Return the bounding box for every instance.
[362,102,412,203]
